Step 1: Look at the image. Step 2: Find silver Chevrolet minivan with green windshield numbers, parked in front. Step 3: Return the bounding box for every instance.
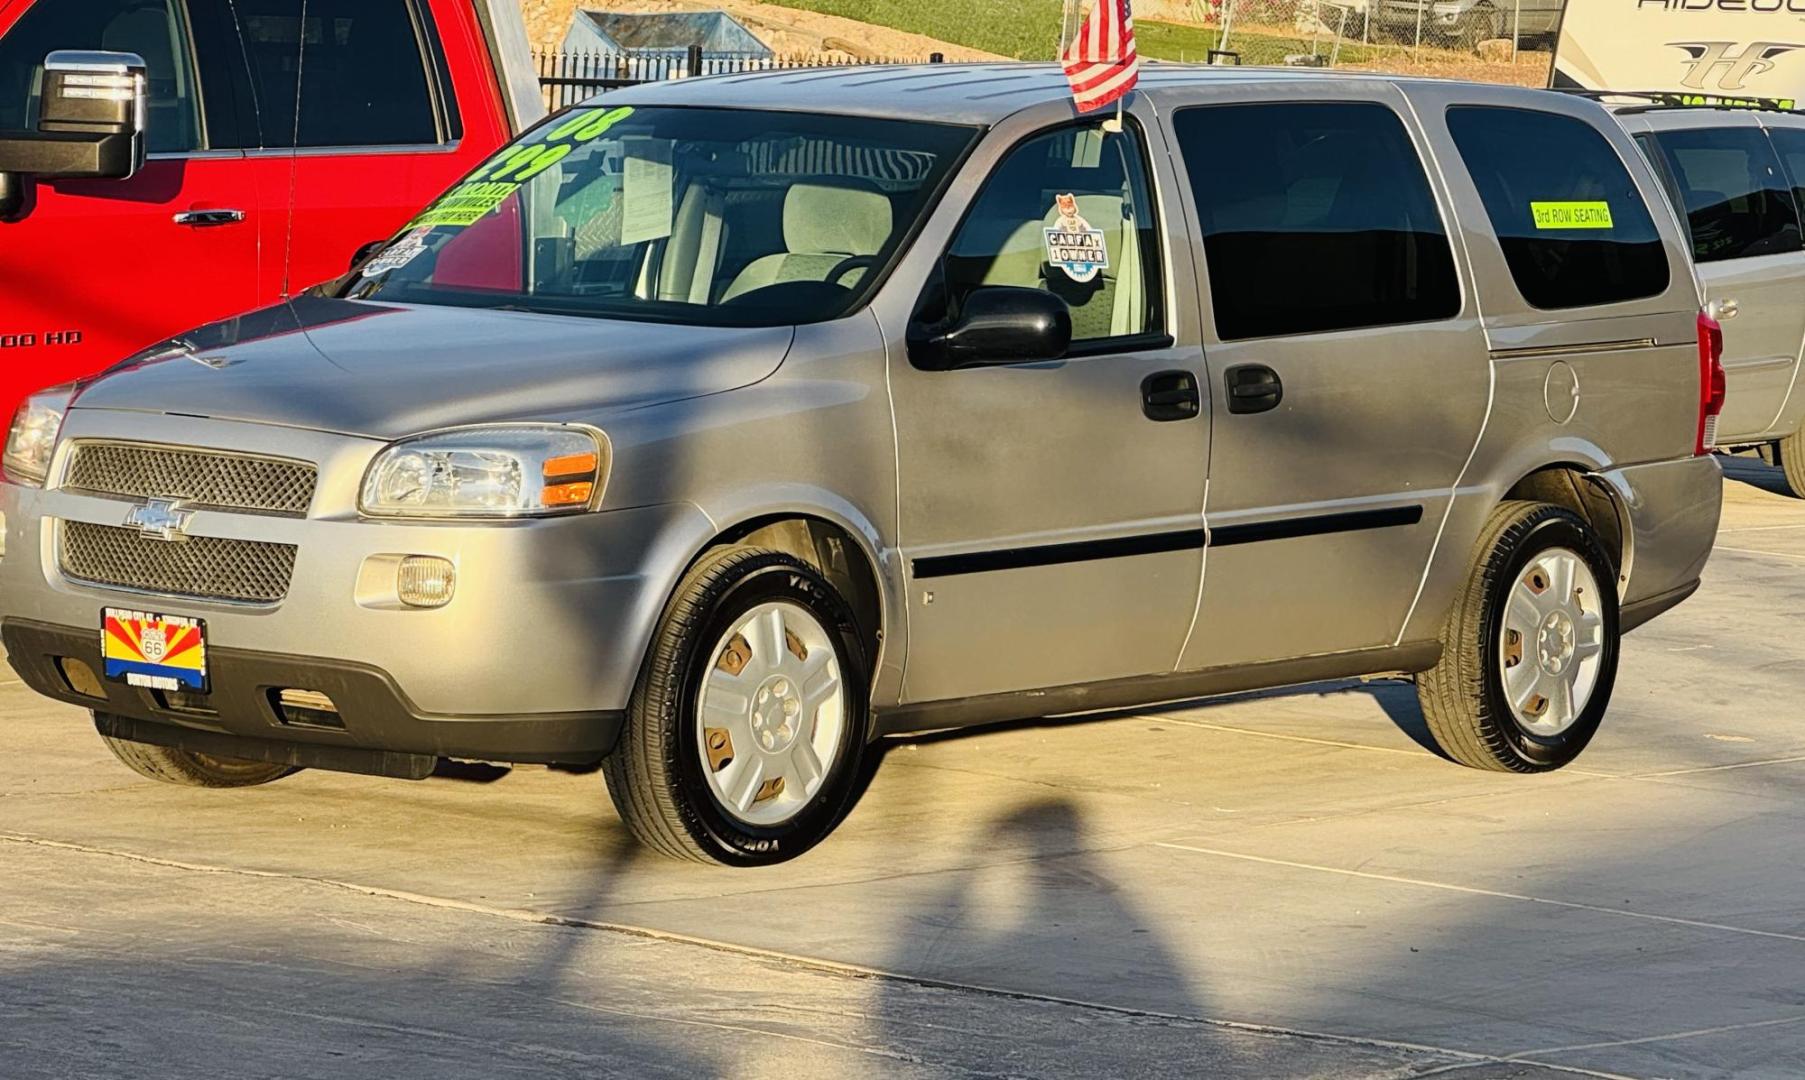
[0,65,1722,865]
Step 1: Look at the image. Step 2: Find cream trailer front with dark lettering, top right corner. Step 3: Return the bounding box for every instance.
[1552,0,1805,108]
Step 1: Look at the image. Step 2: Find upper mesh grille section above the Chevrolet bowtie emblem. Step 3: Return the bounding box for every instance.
[63,442,318,518]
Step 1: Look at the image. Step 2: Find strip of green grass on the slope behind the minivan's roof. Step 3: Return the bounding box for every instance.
[761,0,1374,63]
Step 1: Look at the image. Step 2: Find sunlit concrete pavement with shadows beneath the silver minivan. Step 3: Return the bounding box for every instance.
[0,459,1805,1080]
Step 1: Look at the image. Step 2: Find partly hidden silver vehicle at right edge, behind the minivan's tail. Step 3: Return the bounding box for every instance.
[1614,99,1805,497]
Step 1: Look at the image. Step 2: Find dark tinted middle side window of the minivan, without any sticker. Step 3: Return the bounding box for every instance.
[1173,103,1460,341]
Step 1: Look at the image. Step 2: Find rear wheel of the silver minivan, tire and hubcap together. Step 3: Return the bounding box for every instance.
[1417,502,1619,773]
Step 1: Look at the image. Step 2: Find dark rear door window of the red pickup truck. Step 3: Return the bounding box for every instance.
[236,0,440,148]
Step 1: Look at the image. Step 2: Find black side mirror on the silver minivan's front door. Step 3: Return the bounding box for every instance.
[908,285,1072,372]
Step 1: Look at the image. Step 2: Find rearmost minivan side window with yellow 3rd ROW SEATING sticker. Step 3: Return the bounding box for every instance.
[1448,105,1670,309]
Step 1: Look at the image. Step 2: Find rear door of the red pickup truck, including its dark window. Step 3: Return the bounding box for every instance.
[236,0,511,294]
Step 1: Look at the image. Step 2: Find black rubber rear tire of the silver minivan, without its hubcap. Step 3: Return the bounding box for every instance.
[1417,502,1619,773]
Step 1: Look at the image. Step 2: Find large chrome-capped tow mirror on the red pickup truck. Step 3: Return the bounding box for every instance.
[0,51,148,219]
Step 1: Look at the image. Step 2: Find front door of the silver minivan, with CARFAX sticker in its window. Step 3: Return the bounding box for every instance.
[890,110,1209,703]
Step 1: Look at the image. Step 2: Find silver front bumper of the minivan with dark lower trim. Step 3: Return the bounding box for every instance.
[0,410,713,762]
